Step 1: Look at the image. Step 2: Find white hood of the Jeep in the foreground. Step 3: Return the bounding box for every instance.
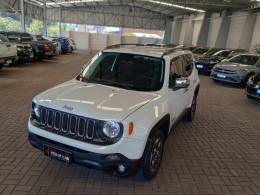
[34,80,159,121]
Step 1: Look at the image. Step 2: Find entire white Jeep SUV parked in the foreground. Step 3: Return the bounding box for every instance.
[28,44,200,180]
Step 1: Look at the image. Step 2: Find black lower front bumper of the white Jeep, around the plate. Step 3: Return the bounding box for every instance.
[28,132,142,176]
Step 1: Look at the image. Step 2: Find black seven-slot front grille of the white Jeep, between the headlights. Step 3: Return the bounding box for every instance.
[35,106,102,142]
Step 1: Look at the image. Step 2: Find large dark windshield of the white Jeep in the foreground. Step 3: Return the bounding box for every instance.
[80,52,164,91]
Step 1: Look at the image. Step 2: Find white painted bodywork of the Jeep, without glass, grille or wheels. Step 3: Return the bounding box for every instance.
[28,46,200,160]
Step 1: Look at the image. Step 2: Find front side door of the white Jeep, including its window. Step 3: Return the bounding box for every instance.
[168,56,187,125]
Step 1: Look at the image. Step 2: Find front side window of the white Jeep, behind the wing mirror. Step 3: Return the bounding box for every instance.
[169,56,185,88]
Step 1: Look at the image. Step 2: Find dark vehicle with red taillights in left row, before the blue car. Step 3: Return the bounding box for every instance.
[32,35,56,58]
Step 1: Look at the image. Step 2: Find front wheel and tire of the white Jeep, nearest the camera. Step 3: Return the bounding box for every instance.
[139,129,165,181]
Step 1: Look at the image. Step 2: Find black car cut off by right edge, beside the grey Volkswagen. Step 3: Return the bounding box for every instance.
[246,72,260,100]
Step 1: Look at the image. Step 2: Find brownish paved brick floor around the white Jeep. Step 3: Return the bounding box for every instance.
[0,53,260,195]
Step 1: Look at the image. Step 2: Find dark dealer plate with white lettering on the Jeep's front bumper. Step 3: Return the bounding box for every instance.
[43,145,72,163]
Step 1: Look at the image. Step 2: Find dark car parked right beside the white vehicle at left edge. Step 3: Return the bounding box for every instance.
[0,32,34,63]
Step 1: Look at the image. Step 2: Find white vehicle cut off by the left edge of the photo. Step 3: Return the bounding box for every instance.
[0,35,17,67]
